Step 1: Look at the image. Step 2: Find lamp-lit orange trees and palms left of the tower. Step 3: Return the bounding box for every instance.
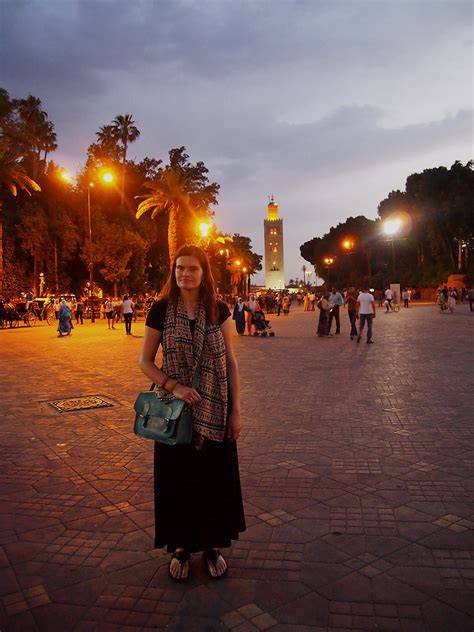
[0,88,259,295]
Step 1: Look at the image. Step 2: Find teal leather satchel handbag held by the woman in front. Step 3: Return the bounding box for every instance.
[133,360,201,445]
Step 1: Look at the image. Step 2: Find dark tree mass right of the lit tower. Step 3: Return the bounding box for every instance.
[301,161,474,287]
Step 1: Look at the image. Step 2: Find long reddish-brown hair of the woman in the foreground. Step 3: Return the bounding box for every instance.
[158,246,218,325]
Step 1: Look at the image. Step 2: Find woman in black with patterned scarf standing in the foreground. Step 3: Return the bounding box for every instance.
[140,246,245,581]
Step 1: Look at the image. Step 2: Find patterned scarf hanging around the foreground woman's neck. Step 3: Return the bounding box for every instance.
[156,297,227,448]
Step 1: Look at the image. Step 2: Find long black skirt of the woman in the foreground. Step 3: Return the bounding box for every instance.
[154,439,245,553]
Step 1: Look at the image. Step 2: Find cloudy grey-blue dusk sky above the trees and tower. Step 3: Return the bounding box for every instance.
[0,0,473,280]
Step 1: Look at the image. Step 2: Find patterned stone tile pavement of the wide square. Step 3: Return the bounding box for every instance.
[0,306,474,632]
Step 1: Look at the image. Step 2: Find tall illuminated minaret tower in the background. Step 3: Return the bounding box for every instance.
[263,195,285,290]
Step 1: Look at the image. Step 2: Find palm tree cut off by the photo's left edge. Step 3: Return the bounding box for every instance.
[0,138,41,294]
